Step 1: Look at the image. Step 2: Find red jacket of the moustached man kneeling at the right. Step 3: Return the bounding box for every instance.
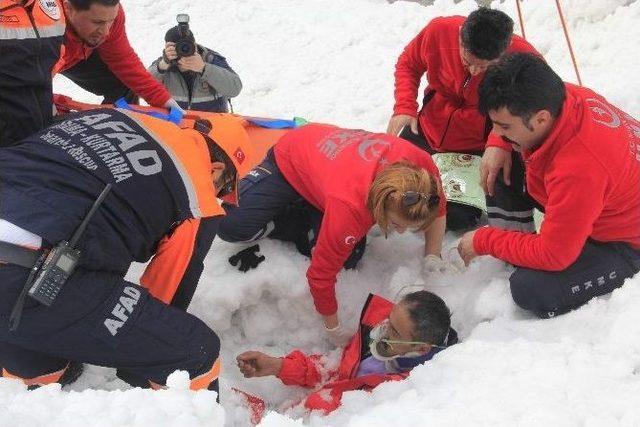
[473,84,640,271]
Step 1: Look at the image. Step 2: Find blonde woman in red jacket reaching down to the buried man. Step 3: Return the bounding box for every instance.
[217,124,446,345]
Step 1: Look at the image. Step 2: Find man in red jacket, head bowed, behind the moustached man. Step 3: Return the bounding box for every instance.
[387,7,539,231]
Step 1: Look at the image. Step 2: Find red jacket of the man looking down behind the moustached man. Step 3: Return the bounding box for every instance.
[393,16,540,152]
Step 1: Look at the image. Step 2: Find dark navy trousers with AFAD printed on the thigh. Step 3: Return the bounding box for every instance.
[0,264,220,389]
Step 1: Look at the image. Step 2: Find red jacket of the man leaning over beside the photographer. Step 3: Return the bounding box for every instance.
[54,6,171,107]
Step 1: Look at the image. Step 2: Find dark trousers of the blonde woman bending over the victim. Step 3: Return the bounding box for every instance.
[218,150,366,268]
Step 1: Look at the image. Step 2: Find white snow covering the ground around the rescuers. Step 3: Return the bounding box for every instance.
[0,0,640,427]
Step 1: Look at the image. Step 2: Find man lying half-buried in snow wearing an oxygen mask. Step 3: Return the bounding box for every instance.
[237,291,458,413]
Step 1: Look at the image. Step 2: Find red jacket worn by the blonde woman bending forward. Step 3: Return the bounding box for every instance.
[274,124,446,316]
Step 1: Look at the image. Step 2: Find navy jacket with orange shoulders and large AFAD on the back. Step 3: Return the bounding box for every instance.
[0,109,221,280]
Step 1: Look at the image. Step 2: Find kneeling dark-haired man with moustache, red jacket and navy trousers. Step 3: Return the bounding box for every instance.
[458,54,640,317]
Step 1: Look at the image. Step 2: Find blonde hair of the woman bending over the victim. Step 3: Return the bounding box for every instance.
[367,161,438,233]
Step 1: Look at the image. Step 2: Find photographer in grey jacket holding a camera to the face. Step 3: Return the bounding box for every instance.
[149,15,242,112]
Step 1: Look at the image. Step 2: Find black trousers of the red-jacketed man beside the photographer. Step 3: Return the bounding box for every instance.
[62,51,138,104]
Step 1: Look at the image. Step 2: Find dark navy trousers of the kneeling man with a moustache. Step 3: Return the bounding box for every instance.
[509,241,640,318]
